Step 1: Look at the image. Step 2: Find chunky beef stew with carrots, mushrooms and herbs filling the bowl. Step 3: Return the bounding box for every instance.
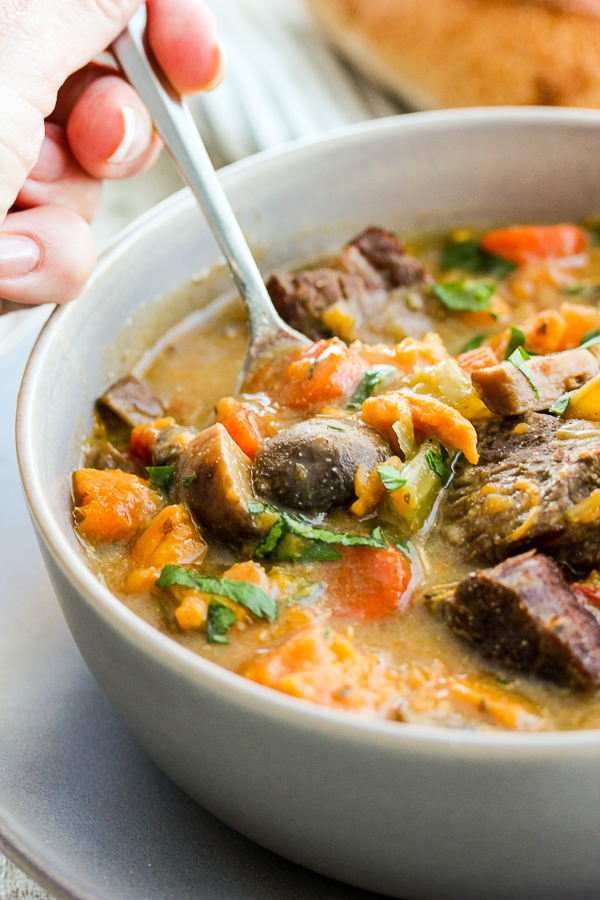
[73,221,600,731]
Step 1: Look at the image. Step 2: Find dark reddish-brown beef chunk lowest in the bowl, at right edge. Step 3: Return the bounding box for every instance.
[443,551,600,689]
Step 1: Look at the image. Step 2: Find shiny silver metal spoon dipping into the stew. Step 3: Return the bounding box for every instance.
[110,4,310,387]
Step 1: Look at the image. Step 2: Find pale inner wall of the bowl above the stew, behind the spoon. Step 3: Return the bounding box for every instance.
[18,110,600,740]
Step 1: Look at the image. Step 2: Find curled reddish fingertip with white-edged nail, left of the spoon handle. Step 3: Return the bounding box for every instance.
[67,75,161,178]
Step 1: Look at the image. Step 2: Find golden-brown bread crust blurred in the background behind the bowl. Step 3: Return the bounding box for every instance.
[307,0,600,109]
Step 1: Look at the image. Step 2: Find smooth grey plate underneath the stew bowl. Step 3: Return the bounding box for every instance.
[0,338,376,900]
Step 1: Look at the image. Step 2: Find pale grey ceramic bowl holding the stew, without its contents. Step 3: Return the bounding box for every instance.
[18,109,600,900]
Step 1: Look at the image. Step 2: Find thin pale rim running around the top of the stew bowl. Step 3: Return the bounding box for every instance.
[16,107,600,759]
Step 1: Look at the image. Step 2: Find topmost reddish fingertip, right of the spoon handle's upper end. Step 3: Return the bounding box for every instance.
[147,0,224,94]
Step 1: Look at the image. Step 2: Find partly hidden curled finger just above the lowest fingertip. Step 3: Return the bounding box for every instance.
[15,122,102,222]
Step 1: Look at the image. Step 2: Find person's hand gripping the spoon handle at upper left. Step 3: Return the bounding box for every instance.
[0,0,223,304]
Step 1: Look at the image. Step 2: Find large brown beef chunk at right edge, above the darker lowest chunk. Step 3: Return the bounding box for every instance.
[440,413,600,571]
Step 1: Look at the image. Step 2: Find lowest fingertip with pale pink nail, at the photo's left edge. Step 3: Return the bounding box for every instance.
[0,206,96,305]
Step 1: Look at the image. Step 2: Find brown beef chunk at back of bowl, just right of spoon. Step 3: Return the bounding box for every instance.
[267,228,430,340]
